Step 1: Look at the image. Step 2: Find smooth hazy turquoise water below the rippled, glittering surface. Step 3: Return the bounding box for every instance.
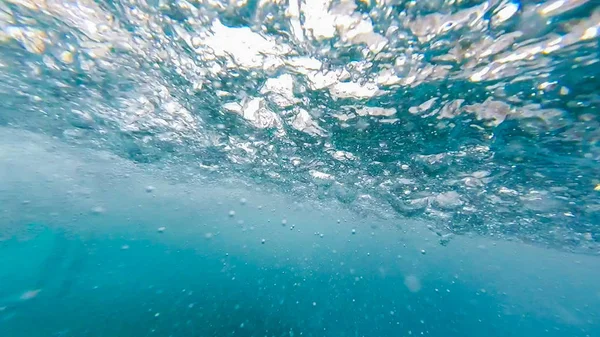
[0,130,600,336]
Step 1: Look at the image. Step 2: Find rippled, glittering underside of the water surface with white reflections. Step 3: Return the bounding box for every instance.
[0,0,600,253]
